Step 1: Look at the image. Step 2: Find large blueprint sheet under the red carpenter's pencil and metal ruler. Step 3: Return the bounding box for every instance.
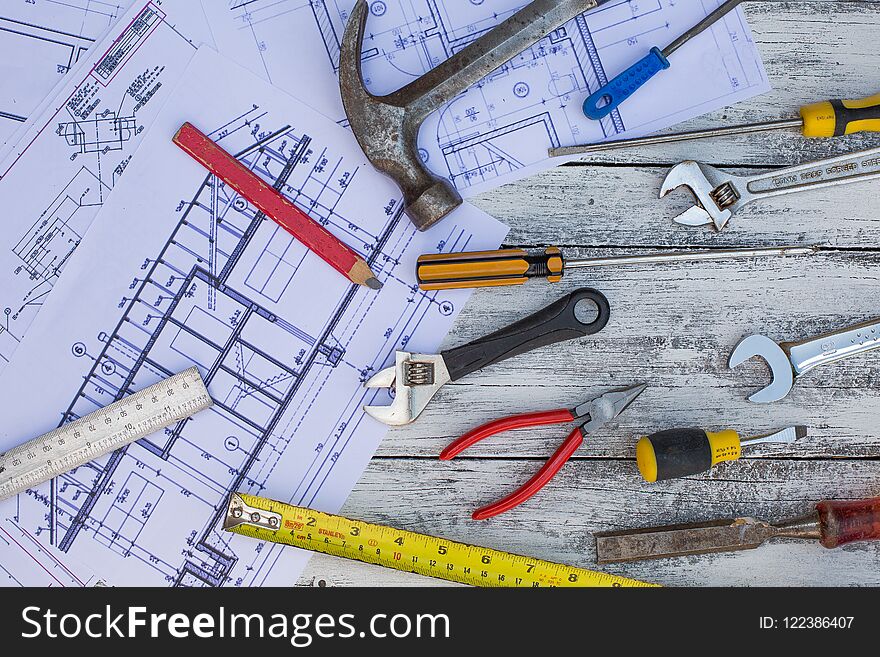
[0,47,507,586]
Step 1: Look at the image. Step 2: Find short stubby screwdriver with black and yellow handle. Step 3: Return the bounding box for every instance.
[636,426,807,483]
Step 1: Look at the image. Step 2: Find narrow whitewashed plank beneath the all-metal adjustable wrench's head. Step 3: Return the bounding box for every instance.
[474,164,880,246]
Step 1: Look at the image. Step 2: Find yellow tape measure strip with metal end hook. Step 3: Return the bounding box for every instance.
[223,493,653,587]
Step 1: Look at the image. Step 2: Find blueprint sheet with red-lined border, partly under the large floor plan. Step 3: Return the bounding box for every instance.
[0,0,211,372]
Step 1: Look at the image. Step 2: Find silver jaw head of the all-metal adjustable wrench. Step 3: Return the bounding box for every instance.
[660,160,739,230]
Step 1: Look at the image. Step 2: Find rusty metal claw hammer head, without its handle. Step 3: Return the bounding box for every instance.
[339,0,462,230]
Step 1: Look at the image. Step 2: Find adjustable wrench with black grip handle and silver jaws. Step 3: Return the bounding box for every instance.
[364,288,611,426]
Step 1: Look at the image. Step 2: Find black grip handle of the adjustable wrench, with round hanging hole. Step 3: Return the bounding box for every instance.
[441,288,611,381]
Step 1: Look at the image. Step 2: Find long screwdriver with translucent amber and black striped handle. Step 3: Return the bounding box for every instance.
[416,246,818,290]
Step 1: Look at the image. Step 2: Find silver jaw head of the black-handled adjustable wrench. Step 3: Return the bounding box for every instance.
[364,351,449,427]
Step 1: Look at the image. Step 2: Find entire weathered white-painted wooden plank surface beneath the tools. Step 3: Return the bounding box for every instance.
[301,0,880,586]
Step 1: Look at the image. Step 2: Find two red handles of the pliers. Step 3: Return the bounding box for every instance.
[440,408,584,520]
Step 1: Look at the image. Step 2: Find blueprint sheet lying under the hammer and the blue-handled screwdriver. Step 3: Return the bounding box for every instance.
[202,0,770,196]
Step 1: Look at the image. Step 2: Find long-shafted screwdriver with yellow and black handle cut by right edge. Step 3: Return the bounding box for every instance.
[549,94,880,157]
